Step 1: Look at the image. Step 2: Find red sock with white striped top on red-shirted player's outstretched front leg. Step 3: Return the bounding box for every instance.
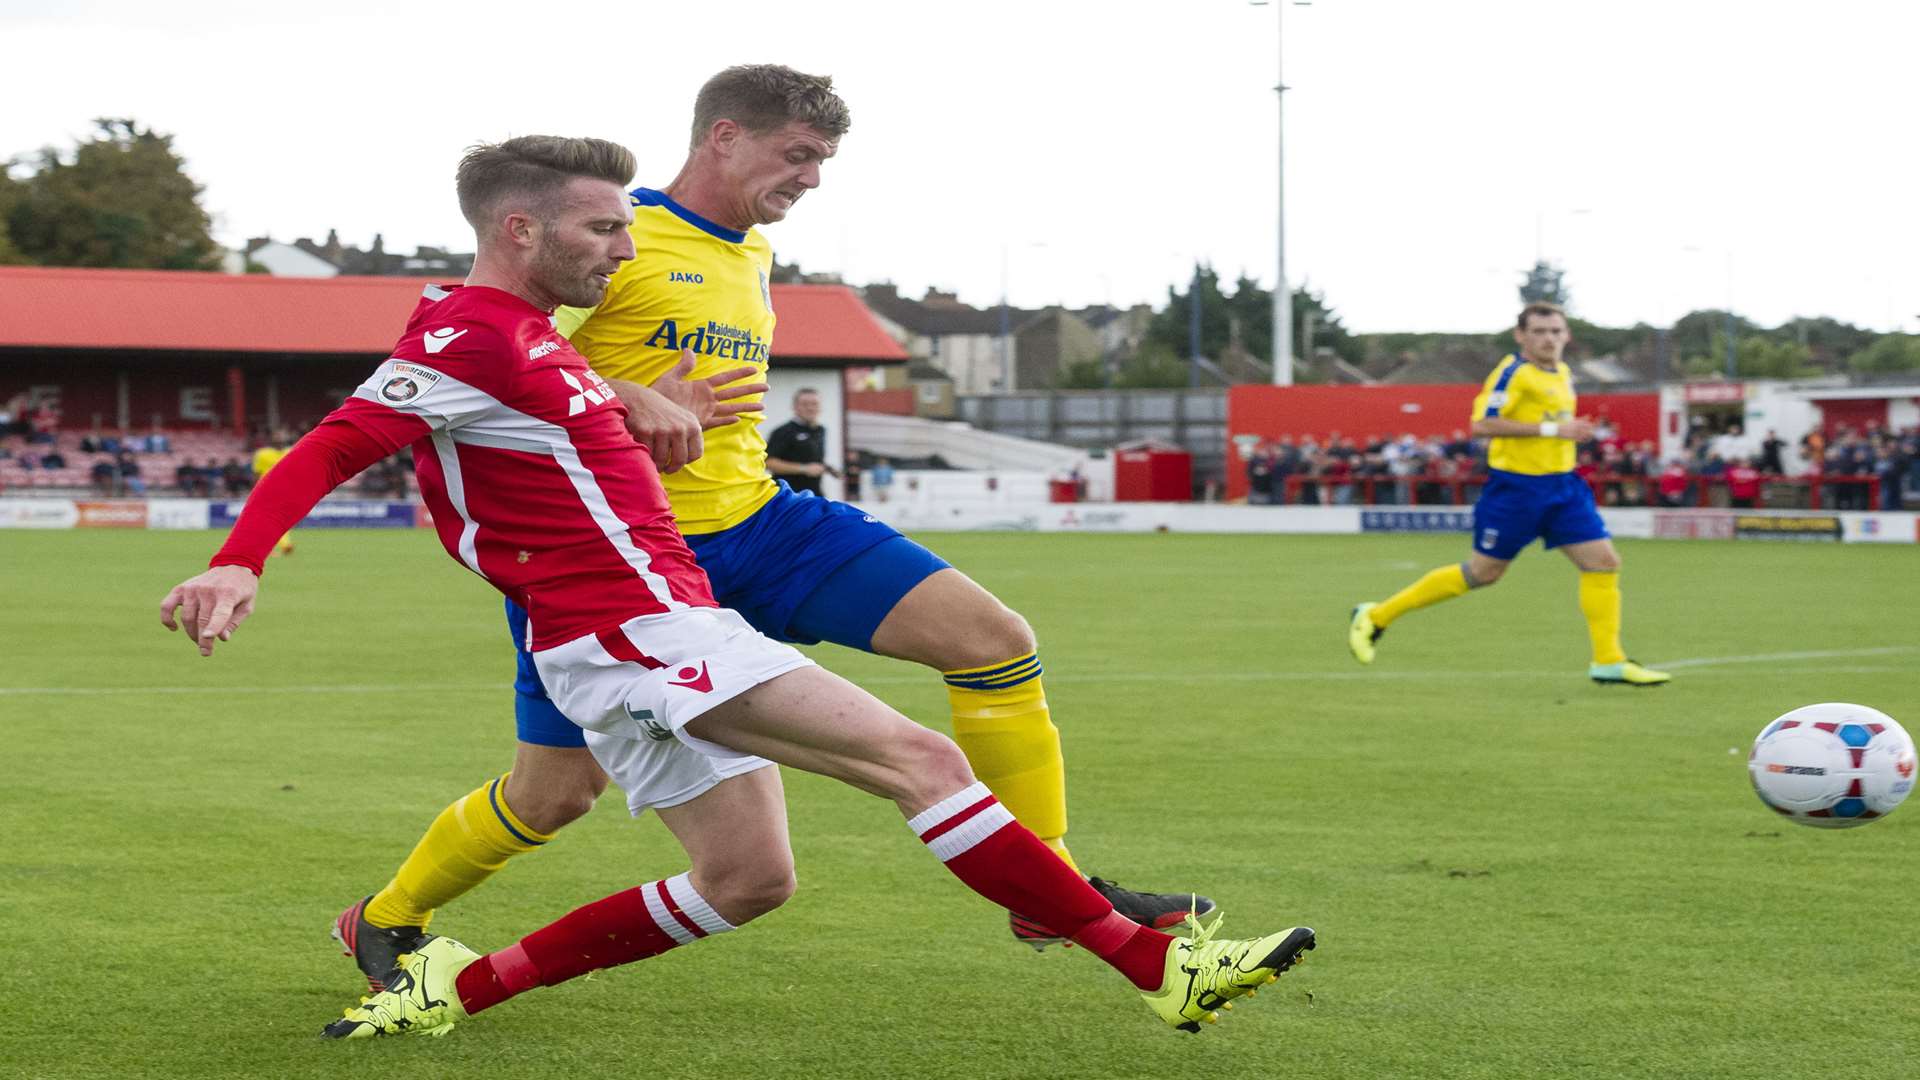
[906,782,1173,990]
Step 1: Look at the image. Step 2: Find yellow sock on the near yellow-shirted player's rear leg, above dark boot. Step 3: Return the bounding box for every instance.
[367,774,553,926]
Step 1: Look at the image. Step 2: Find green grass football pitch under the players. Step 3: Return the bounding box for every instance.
[0,530,1920,1080]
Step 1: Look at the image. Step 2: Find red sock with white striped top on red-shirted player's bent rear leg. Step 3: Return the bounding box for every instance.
[453,874,733,1015]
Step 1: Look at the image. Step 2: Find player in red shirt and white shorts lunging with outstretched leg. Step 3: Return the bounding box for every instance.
[161,136,1313,1038]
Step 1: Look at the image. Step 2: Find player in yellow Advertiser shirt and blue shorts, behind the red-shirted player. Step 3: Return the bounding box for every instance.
[334,65,1213,990]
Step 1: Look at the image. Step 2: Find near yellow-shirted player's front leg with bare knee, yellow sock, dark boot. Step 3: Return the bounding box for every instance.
[872,567,1213,949]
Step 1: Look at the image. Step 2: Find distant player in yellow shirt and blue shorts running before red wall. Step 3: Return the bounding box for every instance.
[1346,304,1672,686]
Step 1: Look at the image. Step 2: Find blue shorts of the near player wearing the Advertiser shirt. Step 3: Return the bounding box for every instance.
[507,482,948,748]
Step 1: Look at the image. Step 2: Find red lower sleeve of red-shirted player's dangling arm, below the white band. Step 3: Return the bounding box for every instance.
[207,417,403,577]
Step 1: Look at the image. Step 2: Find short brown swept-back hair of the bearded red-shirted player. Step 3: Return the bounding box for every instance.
[453,135,639,229]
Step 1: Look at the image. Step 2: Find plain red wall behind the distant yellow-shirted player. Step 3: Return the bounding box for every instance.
[1227,382,1661,498]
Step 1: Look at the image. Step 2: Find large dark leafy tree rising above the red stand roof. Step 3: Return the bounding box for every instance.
[6,119,221,269]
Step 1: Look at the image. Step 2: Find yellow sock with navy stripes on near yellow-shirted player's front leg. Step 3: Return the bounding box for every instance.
[941,653,1079,871]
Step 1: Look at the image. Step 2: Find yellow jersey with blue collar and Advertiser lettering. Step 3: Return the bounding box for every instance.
[555,188,780,534]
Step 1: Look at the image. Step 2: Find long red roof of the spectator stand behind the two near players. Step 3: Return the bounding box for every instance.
[0,267,906,363]
